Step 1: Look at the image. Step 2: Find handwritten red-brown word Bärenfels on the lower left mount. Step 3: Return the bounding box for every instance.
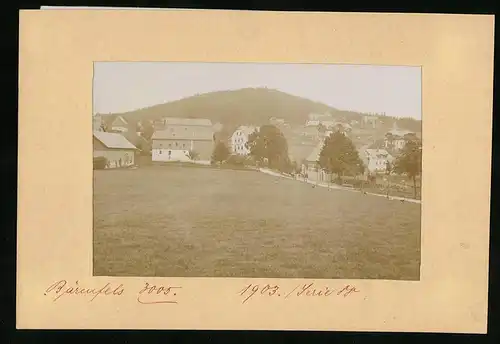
[44,280,125,302]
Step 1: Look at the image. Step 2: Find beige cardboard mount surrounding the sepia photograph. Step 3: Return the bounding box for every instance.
[17,10,494,333]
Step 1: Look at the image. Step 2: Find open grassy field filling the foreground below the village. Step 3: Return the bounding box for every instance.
[93,166,420,280]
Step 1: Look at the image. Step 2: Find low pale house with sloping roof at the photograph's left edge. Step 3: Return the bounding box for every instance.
[93,131,137,168]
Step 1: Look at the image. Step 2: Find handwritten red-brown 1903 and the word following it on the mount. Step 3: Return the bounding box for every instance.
[238,282,359,303]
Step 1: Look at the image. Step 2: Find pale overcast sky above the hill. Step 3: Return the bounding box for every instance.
[94,62,422,119]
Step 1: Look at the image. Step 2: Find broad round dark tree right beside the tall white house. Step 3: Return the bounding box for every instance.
[246,125,290,169]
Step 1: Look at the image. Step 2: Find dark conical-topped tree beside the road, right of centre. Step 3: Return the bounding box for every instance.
[318,132,364,182]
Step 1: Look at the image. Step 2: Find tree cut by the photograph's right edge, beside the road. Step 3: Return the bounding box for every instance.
[393,140,422,198]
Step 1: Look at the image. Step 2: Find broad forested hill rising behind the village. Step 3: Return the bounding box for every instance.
[98,88,420,129]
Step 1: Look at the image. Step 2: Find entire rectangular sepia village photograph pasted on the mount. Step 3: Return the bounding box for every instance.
[93,62,422,281]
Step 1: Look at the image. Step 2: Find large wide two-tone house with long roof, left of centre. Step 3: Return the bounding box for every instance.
[152,117,214,163]
